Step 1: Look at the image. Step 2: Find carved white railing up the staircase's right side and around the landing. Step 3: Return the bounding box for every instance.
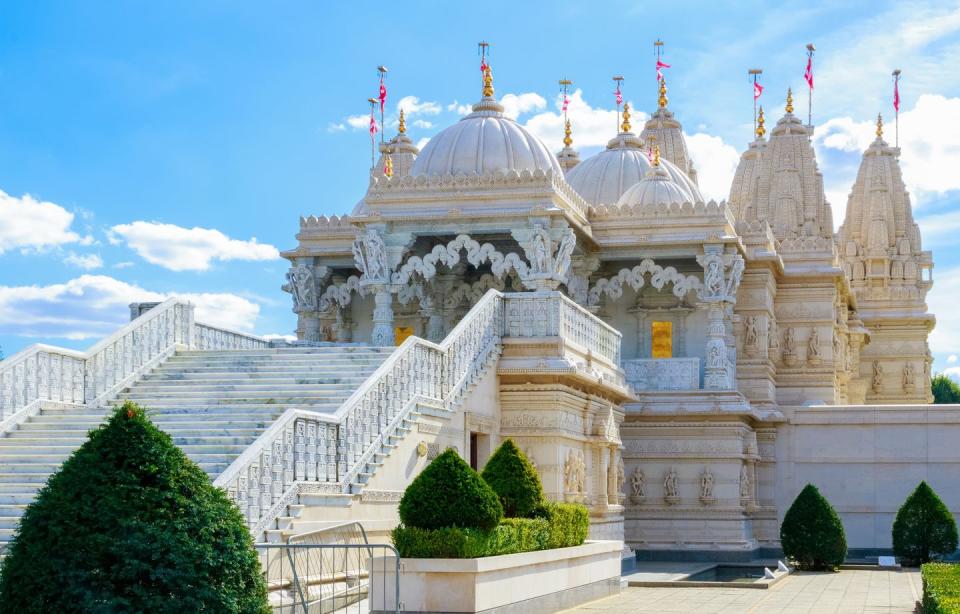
[214,290,620,537]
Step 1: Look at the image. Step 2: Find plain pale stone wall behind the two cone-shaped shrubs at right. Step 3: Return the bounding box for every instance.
[775,405,960,549]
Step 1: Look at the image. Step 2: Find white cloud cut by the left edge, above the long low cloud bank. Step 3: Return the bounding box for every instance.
[0,190,81,254]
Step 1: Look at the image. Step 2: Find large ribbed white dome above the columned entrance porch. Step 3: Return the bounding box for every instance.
[410,96,563,176]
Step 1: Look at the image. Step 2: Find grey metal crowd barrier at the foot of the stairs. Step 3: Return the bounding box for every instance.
[256,543,400,614]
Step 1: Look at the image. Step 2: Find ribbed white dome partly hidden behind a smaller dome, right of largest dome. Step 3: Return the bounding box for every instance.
[567,132,703,205]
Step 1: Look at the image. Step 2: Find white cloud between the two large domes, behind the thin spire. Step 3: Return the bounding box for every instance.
[524,89,647,152]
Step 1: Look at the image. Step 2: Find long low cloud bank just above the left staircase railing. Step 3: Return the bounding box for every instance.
[0,275,260,339]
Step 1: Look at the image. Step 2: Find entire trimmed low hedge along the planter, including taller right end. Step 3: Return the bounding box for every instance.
[393,503,590,559]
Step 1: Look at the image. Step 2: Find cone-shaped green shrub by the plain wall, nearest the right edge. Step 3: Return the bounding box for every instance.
[893,482,957,565]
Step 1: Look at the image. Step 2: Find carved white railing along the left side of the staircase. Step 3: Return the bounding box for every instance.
[0,298,269,432]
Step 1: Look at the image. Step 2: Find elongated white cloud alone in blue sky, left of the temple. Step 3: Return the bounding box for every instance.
[109,221,280,271]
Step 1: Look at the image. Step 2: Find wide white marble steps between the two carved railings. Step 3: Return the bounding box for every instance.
[0,345,393,549]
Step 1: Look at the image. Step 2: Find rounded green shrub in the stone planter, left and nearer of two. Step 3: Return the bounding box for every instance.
[400,449,503,529]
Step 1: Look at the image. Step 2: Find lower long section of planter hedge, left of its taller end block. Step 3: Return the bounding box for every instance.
[393,518,550,559]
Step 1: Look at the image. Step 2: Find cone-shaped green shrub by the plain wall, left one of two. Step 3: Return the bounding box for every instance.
[780,484,847,570]
